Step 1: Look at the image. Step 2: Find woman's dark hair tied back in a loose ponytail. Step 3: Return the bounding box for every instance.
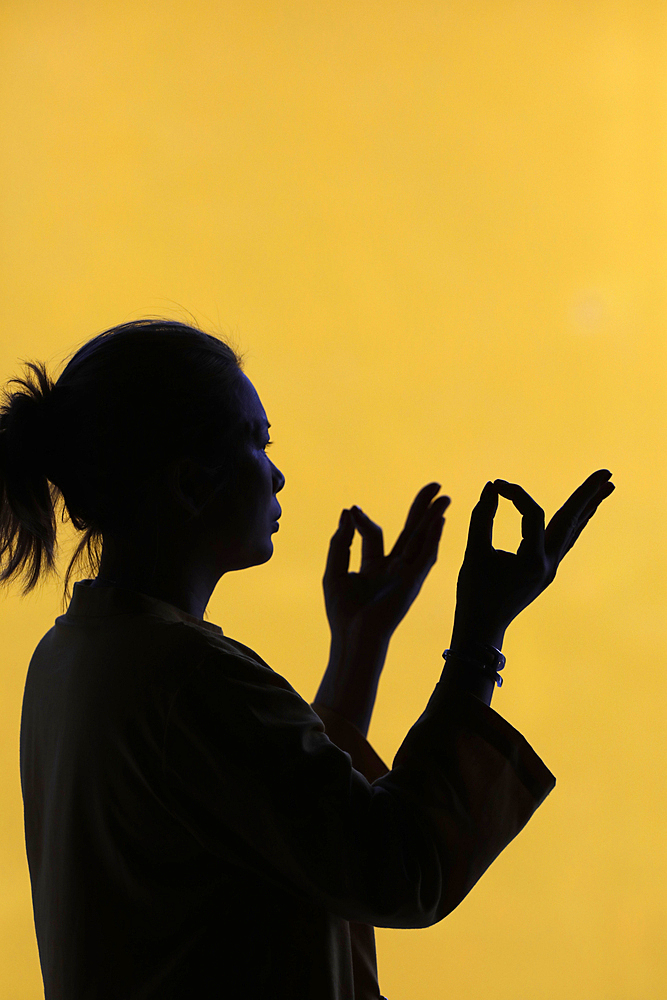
[0,319,243,606]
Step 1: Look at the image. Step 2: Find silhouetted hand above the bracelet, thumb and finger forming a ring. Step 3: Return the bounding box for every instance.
[451,469,615,649]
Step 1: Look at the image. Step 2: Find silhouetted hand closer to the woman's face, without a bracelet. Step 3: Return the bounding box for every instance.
[322,483,450,641]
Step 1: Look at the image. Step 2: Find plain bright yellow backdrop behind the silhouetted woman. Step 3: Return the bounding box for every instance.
[0,0,667,1000]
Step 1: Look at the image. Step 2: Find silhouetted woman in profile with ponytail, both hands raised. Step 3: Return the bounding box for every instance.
[0,320,614,1000]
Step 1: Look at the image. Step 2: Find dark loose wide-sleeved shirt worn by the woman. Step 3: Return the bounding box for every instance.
[20,580,555,1000]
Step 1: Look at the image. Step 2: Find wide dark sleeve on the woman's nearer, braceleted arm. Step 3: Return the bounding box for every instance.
[163,650,555,927]
